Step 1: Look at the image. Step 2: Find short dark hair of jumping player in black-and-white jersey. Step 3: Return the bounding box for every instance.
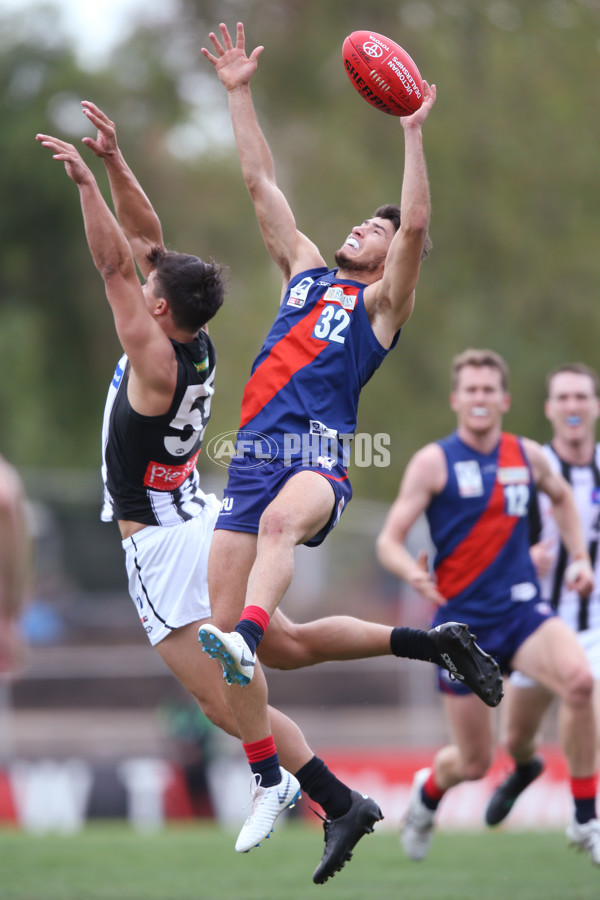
[146,246,225,333]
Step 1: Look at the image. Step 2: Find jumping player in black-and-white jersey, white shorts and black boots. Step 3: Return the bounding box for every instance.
[38,101,499,882]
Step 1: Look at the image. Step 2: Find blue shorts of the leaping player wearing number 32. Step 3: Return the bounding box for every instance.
[215,456,352,547]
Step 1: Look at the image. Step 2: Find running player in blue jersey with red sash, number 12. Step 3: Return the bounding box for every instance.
[378,350,600,865]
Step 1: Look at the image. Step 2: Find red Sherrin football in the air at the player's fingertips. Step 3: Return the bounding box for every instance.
[342,31,423,116]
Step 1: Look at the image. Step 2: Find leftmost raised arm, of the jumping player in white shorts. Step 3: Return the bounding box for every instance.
[36,134,176,402]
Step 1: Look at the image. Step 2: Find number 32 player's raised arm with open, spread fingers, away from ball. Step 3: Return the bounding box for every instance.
[202,22,324,282]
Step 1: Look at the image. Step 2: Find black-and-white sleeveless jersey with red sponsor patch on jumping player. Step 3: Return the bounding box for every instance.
[101,331,216,526]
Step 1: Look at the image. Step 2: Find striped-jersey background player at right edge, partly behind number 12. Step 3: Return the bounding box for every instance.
[485,363,600,825]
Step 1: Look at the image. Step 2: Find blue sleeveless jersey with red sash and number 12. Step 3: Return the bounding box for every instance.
[426,433,539,628]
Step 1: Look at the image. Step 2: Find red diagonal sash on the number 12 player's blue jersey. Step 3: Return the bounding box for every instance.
[435,432,527,600]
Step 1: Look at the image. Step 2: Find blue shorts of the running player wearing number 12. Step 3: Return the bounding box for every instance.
[435,598,556,696]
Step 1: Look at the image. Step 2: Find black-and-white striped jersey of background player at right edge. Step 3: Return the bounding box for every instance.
[538,444,600,631]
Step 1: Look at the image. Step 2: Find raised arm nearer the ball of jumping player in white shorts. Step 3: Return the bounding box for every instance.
[81,100,163,278]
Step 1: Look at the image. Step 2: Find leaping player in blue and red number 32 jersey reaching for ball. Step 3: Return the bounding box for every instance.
[199,23,436,849]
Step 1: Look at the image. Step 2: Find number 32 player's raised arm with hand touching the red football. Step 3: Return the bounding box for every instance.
[365,81,436,346]
